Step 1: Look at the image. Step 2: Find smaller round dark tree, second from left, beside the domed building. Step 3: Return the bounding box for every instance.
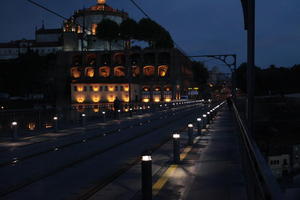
[120,18,138,48]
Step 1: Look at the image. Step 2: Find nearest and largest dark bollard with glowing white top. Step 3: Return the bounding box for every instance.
[142,155,152,200]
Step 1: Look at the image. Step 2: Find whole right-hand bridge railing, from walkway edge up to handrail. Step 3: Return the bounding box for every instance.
[233,103,284,200]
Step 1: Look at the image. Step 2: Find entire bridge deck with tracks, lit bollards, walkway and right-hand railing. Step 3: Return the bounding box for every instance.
[0,101,284,200]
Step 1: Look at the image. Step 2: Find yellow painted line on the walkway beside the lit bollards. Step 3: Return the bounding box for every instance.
[152,137,200,196]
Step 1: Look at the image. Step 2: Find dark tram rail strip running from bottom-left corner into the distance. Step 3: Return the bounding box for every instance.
[0,103,206,197]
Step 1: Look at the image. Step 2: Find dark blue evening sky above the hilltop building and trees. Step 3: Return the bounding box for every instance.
[0,0,300,72]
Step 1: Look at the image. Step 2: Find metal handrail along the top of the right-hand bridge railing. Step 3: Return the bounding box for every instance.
[232,103,284,200]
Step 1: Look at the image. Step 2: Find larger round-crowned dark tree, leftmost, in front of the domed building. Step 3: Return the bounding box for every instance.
[96,19,120,50]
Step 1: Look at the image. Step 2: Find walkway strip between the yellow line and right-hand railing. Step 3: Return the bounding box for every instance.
[154,107,247,200]
